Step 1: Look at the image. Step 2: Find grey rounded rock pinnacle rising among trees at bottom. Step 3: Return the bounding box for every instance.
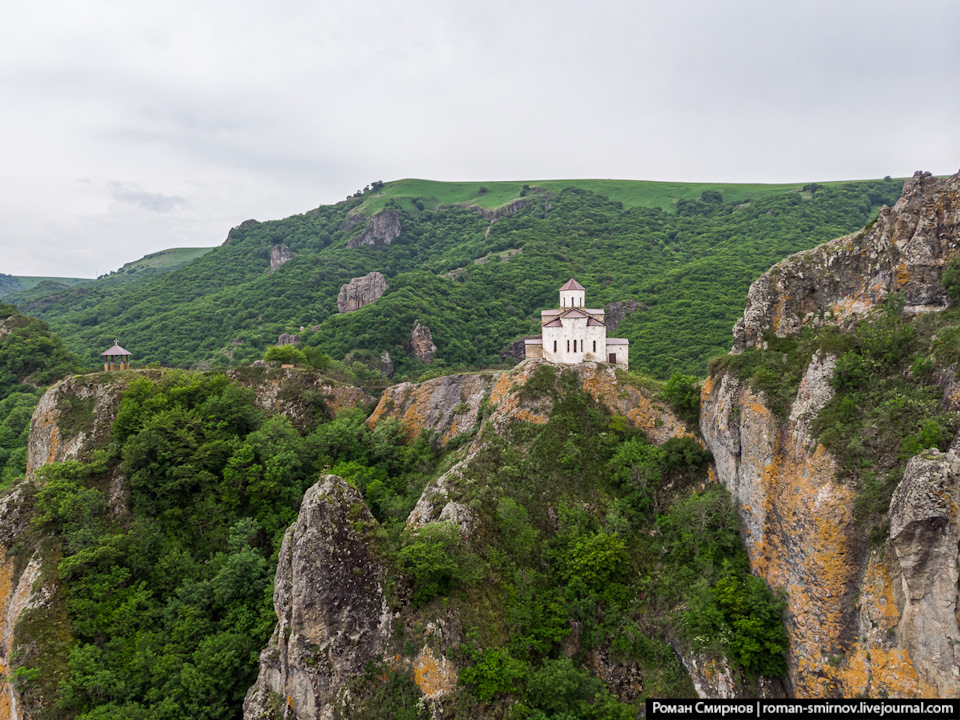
[243,475,393,720]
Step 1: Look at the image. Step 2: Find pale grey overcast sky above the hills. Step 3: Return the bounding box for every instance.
[0,0,960,277]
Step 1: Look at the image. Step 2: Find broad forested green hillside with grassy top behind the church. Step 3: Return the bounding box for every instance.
[13,180,902,378]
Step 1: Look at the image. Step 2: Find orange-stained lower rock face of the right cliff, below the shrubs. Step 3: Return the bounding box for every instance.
[691,356,960,697]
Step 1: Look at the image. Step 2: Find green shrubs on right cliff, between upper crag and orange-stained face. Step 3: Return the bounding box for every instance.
[710,292,960,543]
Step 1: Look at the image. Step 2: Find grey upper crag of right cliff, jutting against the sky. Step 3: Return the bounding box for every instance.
[733,172,960,352]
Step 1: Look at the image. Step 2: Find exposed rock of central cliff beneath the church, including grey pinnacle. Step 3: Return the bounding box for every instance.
[244,360,704,720]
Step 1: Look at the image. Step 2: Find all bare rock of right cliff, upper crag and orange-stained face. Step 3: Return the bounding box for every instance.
[701,173,960,697]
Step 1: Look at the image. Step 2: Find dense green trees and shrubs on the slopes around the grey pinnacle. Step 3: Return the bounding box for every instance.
[19,366,784,719]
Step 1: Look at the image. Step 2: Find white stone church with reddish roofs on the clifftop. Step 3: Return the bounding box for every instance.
[524,278,630,370]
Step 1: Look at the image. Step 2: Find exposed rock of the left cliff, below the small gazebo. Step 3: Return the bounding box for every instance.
[0,368,374,720]
